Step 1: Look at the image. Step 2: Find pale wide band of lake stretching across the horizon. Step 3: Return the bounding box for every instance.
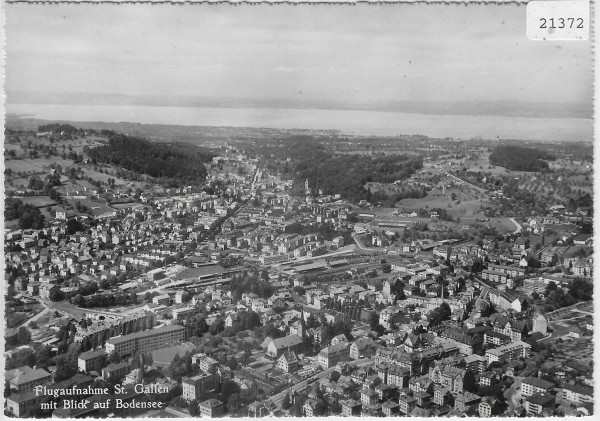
[6,104,593,141]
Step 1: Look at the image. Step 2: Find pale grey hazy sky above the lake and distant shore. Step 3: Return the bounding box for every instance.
[5,4,593,113]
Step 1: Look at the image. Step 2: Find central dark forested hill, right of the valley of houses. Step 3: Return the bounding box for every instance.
[248,136,423,201]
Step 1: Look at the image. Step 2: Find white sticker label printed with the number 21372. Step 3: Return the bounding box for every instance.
[527,0,590,41]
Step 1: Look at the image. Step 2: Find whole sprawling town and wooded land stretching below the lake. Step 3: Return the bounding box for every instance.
[4,120,594,418]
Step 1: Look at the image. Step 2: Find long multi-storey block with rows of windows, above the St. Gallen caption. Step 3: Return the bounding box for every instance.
[106,325,185,357]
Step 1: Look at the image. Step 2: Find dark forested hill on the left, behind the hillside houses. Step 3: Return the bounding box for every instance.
[87,133,216,186]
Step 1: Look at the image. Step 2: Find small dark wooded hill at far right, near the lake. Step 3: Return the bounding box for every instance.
[490,146,556,171]
